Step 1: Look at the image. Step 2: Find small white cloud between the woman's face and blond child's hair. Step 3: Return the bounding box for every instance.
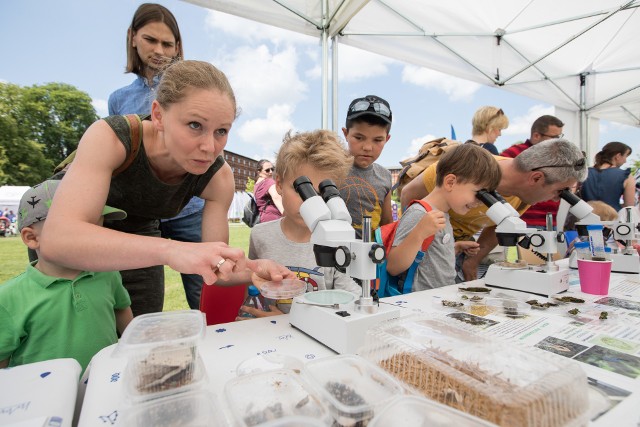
[238,104,295,158]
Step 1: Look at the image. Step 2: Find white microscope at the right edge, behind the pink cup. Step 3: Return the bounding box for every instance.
[558,190,640,274]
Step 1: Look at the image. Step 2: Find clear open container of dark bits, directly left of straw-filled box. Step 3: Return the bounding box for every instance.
[302,355,405,426]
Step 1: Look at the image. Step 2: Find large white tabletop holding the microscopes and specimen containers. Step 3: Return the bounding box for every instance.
[79,273,640,427]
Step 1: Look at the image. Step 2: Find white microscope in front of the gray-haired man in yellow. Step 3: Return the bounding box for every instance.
[477,191,569,296]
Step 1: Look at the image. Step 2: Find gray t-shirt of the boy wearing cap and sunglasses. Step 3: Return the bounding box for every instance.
[340,163,391,239]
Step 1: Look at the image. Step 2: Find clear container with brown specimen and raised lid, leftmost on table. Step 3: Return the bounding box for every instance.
[115,310,206,400]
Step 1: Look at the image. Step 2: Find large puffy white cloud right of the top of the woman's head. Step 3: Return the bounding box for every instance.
[220,44,308,116]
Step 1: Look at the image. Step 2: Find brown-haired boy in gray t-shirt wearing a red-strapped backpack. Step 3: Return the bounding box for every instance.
[387,144,502,291]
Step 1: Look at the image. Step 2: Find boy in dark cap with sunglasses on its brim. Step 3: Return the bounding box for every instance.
[339,95,393,239]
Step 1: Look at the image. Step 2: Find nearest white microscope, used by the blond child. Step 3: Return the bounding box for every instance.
[289,176,400,353]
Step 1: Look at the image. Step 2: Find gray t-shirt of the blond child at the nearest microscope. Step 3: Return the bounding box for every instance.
[249,219,362,313]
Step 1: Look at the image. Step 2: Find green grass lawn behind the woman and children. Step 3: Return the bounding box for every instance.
[0,222,251,311]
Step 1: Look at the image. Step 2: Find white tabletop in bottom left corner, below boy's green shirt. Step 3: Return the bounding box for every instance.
[0,359,82,427]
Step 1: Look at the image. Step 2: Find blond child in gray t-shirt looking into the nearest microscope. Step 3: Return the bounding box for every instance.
[241,130,362,317]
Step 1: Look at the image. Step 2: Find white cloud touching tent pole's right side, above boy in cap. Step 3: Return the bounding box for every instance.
[338,45,397,83]
